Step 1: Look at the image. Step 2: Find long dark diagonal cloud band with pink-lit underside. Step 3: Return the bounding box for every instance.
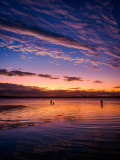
[0,21,96,52]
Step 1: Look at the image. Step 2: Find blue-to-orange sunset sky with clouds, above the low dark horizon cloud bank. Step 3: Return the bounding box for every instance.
[0,0,120,96]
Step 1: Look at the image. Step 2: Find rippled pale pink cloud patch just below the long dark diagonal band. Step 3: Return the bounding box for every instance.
[0,33,77,61]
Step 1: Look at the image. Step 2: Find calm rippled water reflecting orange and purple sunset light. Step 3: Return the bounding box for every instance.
[0,99,120,160]
